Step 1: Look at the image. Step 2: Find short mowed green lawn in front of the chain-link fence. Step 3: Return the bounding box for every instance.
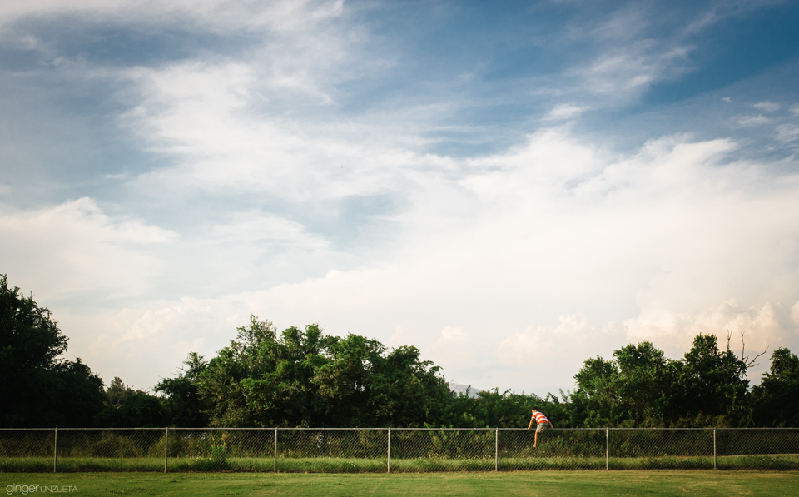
[0,471,799,497]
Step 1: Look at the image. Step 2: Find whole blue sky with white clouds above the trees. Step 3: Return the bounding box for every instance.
[0,0,799,395]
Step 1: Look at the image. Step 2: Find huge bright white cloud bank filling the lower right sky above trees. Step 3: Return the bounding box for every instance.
[72,128,799,391]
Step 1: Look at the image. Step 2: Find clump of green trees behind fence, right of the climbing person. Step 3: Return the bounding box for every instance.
[571,334,750,427]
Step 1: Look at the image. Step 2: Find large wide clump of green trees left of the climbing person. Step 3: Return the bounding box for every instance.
[162,316,451,427]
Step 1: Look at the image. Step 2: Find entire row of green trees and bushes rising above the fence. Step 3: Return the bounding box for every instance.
[0,275,799,428]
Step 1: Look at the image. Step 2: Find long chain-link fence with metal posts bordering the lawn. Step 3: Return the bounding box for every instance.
[0,428,799,473]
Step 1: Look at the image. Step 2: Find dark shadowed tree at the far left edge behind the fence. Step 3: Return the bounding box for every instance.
[0,275,105,427]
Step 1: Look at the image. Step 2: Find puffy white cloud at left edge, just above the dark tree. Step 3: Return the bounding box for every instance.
[0,197,178,300]
